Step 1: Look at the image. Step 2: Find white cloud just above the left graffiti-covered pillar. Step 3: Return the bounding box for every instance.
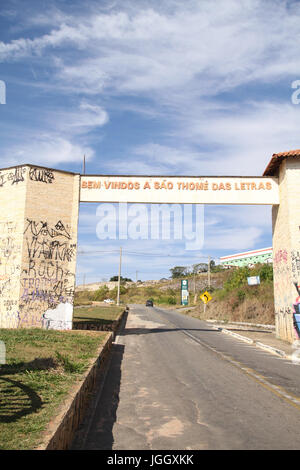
[1,101,109,166]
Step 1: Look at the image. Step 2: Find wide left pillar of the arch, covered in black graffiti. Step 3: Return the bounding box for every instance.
[0,165,80,329]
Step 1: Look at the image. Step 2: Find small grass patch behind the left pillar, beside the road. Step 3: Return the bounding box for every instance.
[73,305,124,324]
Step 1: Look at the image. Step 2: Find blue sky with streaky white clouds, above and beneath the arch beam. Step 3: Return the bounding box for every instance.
[0,0,300,282]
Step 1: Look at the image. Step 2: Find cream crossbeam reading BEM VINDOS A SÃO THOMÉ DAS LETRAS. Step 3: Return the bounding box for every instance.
[80,175,279,205]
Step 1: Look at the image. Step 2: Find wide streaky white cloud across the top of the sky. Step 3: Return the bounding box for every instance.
[0,0,300,96]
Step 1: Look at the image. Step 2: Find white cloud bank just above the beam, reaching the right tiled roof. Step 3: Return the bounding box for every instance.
[108,102,300,176]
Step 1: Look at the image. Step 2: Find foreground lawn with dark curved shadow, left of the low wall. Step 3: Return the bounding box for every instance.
[0,329,107,450]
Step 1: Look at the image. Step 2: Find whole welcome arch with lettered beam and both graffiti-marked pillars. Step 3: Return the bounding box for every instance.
[0,150,300,342]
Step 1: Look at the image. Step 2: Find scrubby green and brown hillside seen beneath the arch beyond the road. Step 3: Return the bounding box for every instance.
[75,264,275,324]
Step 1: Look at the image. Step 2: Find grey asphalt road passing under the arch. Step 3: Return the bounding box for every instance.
[72,305,300,450]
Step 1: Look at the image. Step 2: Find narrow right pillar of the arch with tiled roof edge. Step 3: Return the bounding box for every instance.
[264,150,300,342]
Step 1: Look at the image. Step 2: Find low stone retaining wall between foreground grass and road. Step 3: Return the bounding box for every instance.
[36,333,114,450]
